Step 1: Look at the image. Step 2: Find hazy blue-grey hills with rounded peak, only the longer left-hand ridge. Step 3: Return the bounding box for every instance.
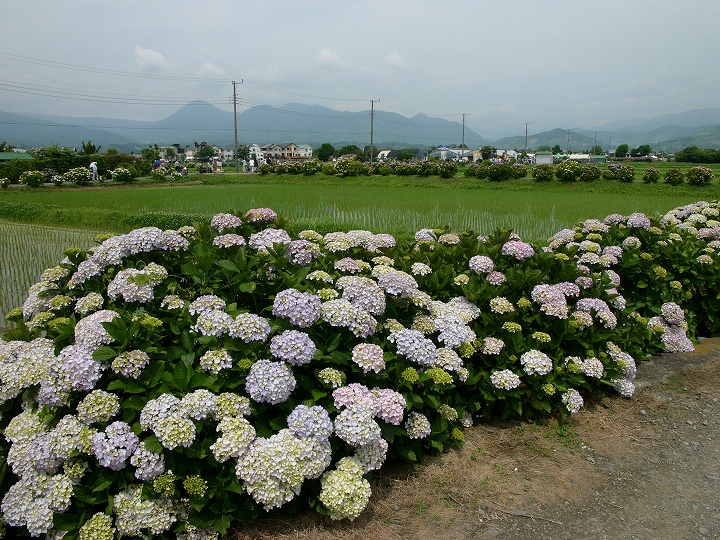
[0,101,487,148]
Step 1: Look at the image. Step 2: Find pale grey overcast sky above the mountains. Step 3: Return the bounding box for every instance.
[0,0,720,139]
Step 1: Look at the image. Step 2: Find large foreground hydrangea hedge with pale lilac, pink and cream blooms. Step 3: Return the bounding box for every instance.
[0,202,720,539]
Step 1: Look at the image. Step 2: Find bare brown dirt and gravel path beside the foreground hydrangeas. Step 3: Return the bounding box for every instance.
[228,337,720,540]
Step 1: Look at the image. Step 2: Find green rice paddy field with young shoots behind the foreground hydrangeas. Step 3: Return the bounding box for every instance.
[0,174,720,327]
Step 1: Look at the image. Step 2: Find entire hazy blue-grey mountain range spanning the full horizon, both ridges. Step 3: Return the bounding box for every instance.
[0,101,720,152]
